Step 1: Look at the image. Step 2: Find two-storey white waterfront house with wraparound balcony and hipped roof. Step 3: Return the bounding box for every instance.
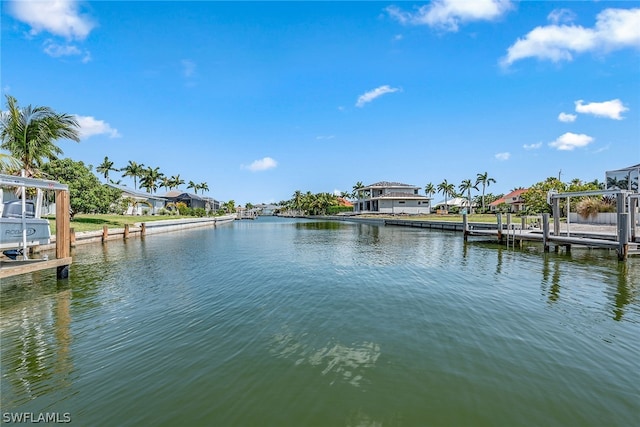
[353,181,431,215]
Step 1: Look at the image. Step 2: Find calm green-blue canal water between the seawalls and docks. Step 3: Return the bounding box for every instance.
[0,218,640,426]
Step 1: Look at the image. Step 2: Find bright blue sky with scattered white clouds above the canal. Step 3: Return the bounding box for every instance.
[0,0,640,204]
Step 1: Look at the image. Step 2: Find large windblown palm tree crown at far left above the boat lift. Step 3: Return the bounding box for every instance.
[0,96,80,176]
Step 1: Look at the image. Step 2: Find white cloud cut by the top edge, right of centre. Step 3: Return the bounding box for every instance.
[386,0,512,31]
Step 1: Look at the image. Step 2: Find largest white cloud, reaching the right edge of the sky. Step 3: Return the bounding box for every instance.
[501,9,640,66]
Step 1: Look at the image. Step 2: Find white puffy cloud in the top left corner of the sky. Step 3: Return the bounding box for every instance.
[8,0,95,40]
